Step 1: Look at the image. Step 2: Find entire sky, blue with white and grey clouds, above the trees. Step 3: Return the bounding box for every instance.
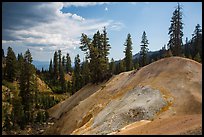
[2,2,202,62]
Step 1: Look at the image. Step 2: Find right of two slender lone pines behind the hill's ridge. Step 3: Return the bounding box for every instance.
[140,31,149,66]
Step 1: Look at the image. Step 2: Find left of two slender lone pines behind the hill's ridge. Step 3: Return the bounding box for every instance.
[124,34,133,71]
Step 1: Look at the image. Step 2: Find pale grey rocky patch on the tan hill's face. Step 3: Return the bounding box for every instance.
[81,86,168,134]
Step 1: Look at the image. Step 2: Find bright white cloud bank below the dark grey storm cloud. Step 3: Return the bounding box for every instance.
[2,2,122,60]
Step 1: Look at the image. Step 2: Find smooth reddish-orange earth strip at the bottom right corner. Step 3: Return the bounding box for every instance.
[116,114,202,135]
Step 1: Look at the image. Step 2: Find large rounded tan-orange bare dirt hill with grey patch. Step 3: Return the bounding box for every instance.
[45,57,202,134]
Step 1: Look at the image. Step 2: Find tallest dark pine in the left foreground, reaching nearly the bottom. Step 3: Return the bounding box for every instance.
[20,50,37,123]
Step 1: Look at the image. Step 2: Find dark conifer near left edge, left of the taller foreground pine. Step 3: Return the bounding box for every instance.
[5,47,17,82]
